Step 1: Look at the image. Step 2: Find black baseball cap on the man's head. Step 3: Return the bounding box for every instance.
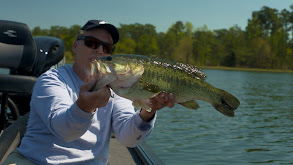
[80,20,119,44]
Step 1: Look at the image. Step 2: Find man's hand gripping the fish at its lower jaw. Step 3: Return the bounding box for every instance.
[76,80,111,113]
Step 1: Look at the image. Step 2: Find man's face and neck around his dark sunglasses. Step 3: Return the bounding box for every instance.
[72,29,113,81]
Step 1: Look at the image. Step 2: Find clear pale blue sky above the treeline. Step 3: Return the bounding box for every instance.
[0,0,293,32]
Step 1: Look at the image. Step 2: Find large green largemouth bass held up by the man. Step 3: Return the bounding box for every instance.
[90,54,240,117]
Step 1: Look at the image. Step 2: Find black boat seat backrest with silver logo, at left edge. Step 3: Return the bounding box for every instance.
[0,20,36,74]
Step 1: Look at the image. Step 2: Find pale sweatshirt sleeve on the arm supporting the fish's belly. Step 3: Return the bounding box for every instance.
[112,95,156,147]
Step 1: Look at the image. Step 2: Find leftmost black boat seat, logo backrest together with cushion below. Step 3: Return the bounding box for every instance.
[0,20,37,95]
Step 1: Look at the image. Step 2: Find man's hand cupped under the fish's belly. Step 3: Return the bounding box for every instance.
[140,92,175,121]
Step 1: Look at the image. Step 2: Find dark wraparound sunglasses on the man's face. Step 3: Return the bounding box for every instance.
[77,36,115,54]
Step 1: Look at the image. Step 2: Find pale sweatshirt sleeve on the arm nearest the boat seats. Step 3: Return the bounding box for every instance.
[31,71,94,141]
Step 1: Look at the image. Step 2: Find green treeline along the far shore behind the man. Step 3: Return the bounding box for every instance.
[32,5,293,70]
